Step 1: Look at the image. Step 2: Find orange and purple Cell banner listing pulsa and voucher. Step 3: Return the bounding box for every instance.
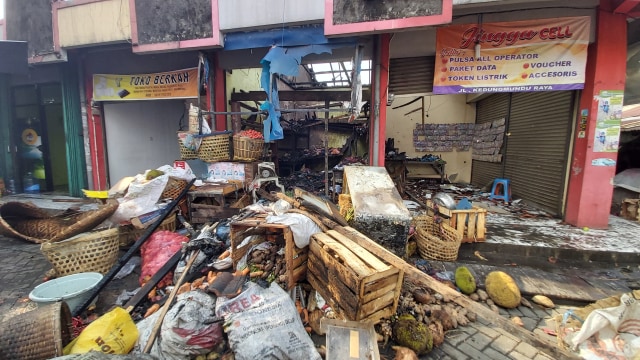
[433,16,590,94]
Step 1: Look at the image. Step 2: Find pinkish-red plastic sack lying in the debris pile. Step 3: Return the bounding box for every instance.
[139,230,189,288]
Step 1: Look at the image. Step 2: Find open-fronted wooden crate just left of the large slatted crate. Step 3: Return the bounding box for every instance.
[230,218,309,290]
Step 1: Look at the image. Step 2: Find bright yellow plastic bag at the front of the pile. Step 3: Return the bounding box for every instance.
[64,307,138,355]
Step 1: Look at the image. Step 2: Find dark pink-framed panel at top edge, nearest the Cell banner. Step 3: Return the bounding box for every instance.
[333,0,442,25]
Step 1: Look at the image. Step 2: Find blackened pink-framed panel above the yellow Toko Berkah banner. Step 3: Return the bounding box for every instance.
[135,0,213,45]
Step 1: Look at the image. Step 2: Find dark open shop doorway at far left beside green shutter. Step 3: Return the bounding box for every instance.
[12,83,69,193]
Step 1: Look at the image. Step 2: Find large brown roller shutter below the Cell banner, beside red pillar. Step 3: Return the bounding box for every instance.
[504,91,575,215]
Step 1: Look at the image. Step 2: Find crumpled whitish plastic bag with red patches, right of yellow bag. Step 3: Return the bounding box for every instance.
[134,291,223,360]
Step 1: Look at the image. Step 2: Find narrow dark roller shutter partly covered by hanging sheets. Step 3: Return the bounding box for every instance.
[471,94,510,187]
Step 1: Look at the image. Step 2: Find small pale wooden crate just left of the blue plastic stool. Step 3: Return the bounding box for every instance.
[427,200,487,243]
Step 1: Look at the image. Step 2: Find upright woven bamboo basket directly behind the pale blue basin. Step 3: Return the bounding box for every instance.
[40,228,120,276]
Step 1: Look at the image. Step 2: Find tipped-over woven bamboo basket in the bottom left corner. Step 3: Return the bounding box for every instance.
[0,301,72,360]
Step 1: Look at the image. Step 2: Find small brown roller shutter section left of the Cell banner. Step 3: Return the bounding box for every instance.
[389,56,435,95]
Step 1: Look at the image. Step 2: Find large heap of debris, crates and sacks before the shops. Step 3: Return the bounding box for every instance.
[5,163,627,360]
